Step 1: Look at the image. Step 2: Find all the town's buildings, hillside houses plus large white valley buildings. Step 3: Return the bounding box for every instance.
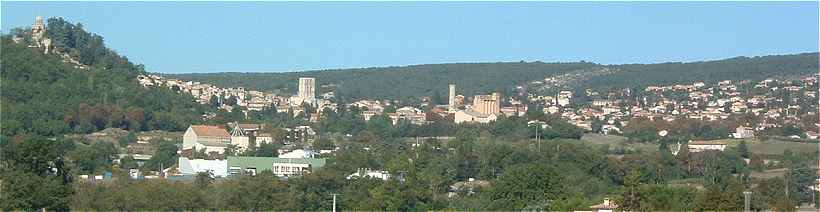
[123,71,820,197]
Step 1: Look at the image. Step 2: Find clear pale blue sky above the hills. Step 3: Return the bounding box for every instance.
[0,1,820,73]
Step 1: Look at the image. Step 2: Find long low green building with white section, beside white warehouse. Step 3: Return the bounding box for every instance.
[228,156,326,177]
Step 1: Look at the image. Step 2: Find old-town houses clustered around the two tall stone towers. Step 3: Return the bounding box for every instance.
[138,74,527,125]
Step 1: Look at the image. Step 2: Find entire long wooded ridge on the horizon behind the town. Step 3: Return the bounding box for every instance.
[171,53,818,101]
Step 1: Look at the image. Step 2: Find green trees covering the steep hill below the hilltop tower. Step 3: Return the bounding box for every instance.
[0,23,210,136]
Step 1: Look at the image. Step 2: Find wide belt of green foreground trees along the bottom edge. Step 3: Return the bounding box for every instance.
[52,131,817,211]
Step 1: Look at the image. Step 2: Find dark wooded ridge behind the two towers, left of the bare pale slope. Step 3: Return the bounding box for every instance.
[172,62,598,100]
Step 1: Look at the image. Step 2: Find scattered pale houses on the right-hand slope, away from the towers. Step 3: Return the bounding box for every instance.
[529,75,818,139]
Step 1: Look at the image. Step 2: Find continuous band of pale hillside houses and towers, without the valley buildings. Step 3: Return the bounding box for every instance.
[139,71,820,139]
